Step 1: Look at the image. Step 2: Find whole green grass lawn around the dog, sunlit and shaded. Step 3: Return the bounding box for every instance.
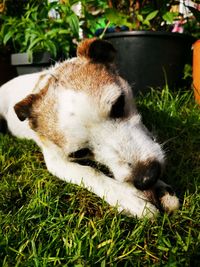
[0,88,200,267]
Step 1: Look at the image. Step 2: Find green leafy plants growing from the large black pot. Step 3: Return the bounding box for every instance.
[94,0,178,30]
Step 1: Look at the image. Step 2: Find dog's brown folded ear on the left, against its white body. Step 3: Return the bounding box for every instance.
[14,94,38,121]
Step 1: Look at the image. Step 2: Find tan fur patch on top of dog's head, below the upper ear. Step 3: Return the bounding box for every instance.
[55,58,121,96]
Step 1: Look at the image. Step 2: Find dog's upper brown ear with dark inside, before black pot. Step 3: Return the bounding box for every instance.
[77,38,116,64]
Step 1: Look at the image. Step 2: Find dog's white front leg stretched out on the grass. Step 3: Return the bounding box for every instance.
[43,149,157,217]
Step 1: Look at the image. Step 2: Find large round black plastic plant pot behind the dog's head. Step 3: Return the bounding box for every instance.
[105,31,195,93]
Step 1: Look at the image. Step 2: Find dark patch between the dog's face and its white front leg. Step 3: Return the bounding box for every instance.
[69,148,114,179]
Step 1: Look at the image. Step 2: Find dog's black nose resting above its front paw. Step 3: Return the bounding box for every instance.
[134,161,161,190]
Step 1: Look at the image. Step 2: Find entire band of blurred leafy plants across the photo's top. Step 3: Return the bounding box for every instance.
[0,0,200,58]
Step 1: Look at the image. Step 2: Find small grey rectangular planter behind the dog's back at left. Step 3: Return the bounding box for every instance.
[11,52,52,75]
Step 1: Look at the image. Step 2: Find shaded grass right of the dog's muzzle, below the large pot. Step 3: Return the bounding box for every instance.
[138,91,200,198]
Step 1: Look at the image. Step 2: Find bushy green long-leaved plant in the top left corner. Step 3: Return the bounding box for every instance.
[0,0,79,57]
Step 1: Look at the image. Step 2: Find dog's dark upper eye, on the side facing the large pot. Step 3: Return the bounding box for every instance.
[110,94,125,119]
